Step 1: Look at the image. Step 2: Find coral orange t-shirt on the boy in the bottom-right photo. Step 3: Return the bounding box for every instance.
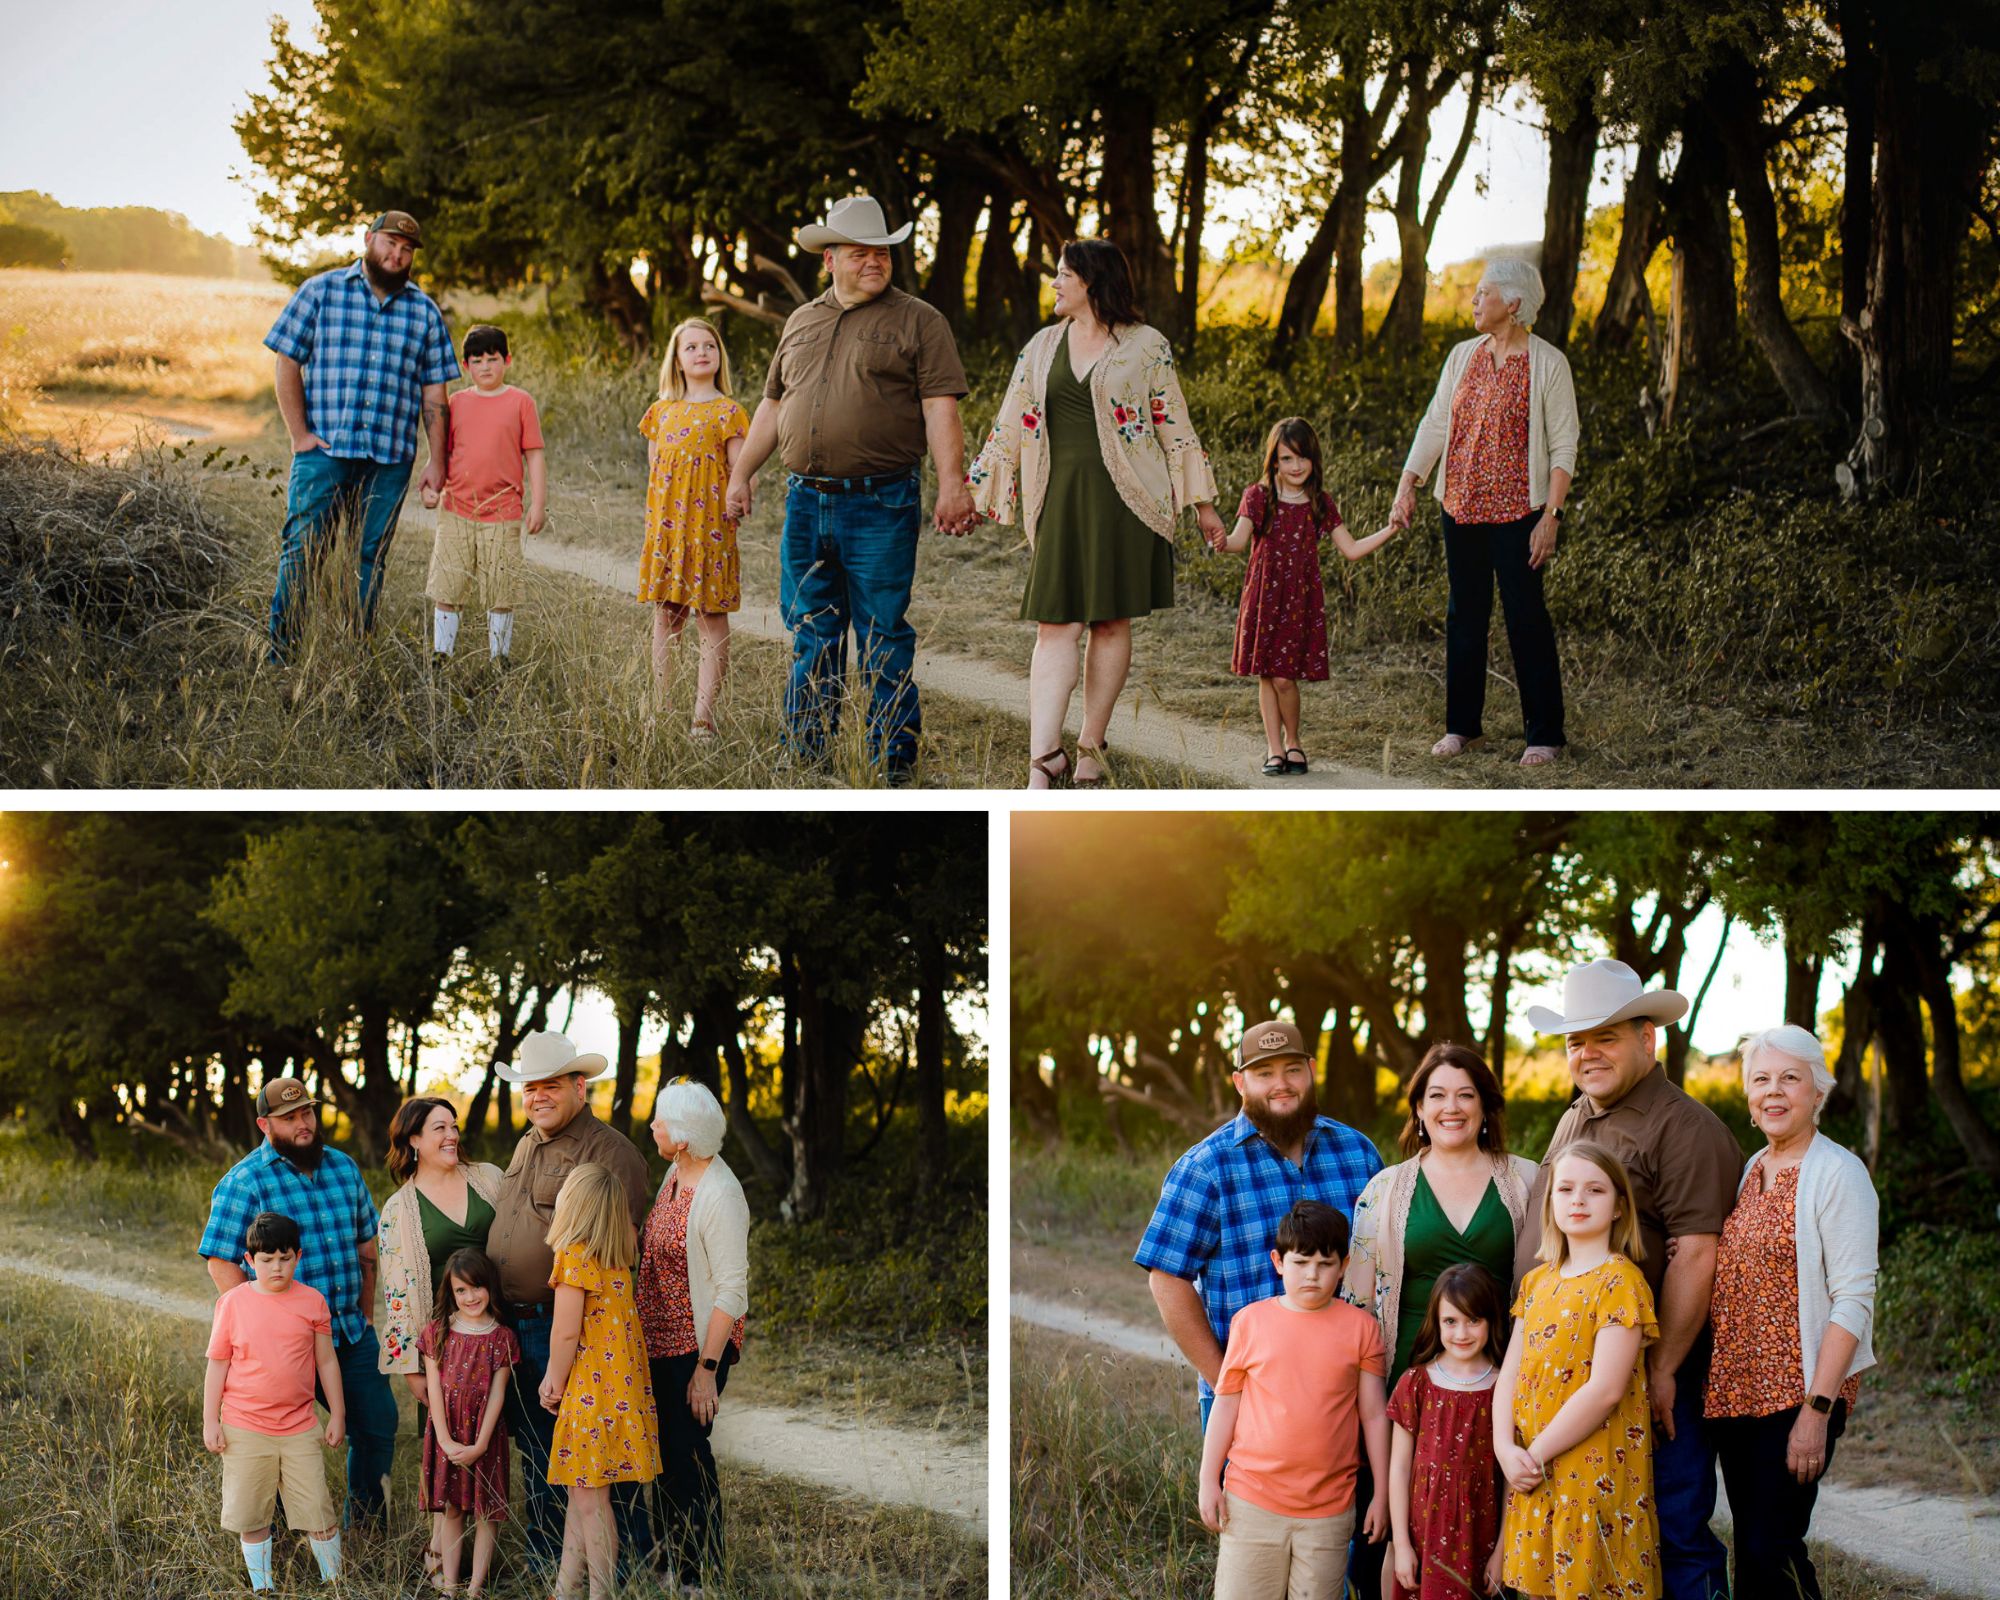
[1216,1296,1388,1516]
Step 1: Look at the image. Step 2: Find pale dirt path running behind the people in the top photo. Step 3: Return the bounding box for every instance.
[524,538,1408,794]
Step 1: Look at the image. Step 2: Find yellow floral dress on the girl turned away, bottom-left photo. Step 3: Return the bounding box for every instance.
[548,1244,660,1488]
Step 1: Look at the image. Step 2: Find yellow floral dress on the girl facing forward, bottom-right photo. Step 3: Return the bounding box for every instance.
[1500,1256,1660,1600]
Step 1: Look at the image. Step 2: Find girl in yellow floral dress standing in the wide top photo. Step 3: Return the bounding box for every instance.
[638,316,750,738]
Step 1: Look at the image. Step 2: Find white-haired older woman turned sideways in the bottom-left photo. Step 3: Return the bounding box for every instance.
[638,1078,750,1594]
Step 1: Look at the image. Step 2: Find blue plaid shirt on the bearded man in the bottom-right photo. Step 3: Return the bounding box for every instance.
[1132,1112,1382,1396]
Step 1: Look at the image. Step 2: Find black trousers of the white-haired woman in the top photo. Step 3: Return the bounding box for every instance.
[1444,512,1566,746]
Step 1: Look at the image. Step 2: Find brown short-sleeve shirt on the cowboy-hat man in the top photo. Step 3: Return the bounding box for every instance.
[764,288,966,478]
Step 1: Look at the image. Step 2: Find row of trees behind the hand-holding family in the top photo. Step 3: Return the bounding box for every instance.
[238,0,2000,488]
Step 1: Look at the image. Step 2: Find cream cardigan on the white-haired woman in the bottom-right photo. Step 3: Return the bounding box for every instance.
[1736,1132,1882,1394]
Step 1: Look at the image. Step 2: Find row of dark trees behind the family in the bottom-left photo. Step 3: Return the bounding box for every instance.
[0,812,986,1218]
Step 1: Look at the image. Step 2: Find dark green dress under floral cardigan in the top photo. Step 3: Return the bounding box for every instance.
[1020,330,1174,622]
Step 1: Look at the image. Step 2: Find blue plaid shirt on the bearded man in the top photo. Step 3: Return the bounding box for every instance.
[264,262,458,466]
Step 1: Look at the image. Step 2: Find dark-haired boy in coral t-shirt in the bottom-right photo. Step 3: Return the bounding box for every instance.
[1202,1200,1388,1600]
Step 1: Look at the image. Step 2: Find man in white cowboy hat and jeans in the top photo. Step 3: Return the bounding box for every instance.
[728,194,978,784]
